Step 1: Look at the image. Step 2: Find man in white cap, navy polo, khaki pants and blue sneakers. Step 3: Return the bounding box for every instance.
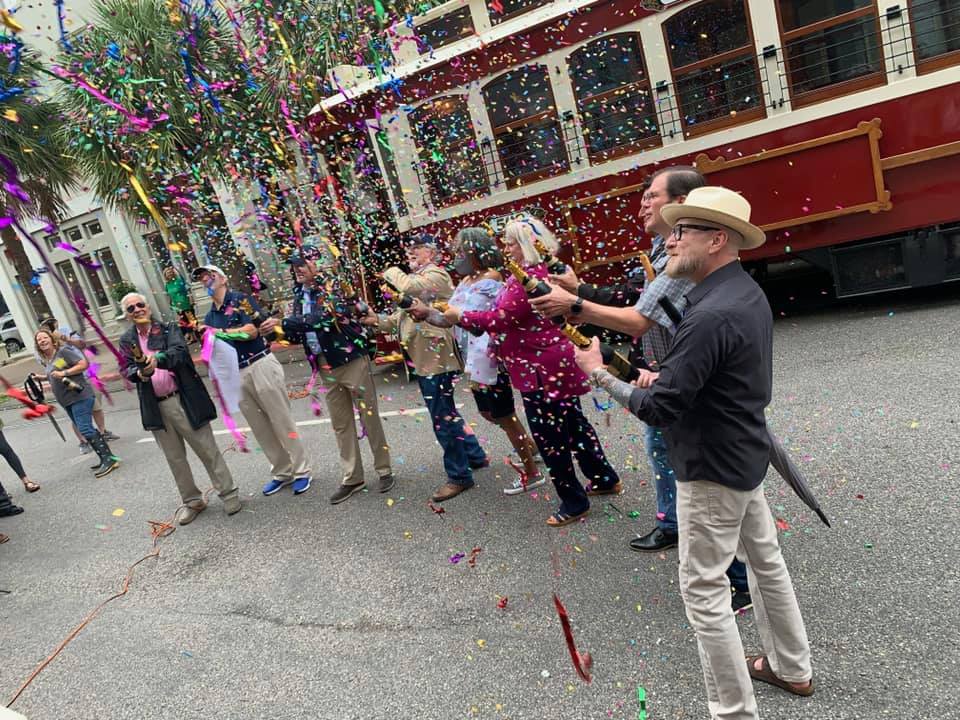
[193,265,310,495]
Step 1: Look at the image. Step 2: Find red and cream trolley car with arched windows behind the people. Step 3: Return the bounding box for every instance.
[310,0,960,296]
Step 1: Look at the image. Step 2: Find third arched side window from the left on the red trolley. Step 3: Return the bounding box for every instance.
[568,34,660,162]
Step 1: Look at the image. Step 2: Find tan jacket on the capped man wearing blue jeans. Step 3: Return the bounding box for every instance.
[378,265,463,376]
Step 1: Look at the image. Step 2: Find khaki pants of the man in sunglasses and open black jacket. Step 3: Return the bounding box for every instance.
[153,396,237,505]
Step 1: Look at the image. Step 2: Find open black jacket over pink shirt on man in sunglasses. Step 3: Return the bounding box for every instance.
[119,321,217,430]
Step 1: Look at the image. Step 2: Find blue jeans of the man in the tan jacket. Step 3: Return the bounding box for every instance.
[417,372,487,487]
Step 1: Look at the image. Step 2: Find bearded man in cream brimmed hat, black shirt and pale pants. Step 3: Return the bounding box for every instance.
[577,187,813,720]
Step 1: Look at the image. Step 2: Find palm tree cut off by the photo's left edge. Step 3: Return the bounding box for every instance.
[0,35,77,315]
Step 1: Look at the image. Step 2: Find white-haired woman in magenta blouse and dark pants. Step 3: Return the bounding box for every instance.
[444,218,621,527]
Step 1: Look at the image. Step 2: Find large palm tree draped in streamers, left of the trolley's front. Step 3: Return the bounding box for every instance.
[54,0,252,284]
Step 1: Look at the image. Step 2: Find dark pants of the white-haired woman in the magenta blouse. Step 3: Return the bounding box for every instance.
[520,390,620,515]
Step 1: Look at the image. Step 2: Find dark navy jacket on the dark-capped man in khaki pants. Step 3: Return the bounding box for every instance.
[281,285,372,368]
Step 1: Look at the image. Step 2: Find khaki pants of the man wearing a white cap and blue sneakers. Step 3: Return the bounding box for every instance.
[240,355,310,482]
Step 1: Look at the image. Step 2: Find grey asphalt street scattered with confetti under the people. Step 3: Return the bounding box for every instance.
[0,278,960,720]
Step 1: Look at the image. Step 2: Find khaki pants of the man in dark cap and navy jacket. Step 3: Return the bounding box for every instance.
[320,357,391,485]
